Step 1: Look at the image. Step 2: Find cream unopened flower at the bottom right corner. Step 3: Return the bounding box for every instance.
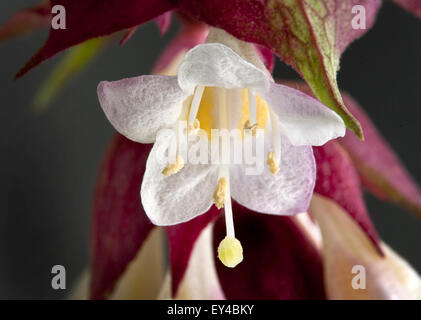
[310,194,421,300]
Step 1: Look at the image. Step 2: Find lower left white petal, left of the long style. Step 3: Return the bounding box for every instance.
[141,133,218,226]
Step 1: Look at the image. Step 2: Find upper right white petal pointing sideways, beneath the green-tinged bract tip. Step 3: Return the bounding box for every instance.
[261,83,346,146]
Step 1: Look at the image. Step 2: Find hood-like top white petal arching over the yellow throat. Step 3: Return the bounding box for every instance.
[178,43,270,94]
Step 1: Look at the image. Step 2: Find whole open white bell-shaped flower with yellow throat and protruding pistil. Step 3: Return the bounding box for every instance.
[98,33,345,267]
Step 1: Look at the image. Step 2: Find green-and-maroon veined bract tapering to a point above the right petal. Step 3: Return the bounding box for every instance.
[269,0,380,139]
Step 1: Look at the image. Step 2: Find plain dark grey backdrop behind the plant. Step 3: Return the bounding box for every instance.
[0,0,421,299]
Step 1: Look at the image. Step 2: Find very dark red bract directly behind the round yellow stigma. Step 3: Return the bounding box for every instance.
[214,204,325,300]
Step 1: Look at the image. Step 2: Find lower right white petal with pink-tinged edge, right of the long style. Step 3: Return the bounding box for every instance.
[231,137,316,215]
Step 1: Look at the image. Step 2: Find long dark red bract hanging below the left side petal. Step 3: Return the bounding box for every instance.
[90,135,154,299]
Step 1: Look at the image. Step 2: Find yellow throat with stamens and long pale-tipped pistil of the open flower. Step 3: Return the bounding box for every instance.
[163,86,281,268]
